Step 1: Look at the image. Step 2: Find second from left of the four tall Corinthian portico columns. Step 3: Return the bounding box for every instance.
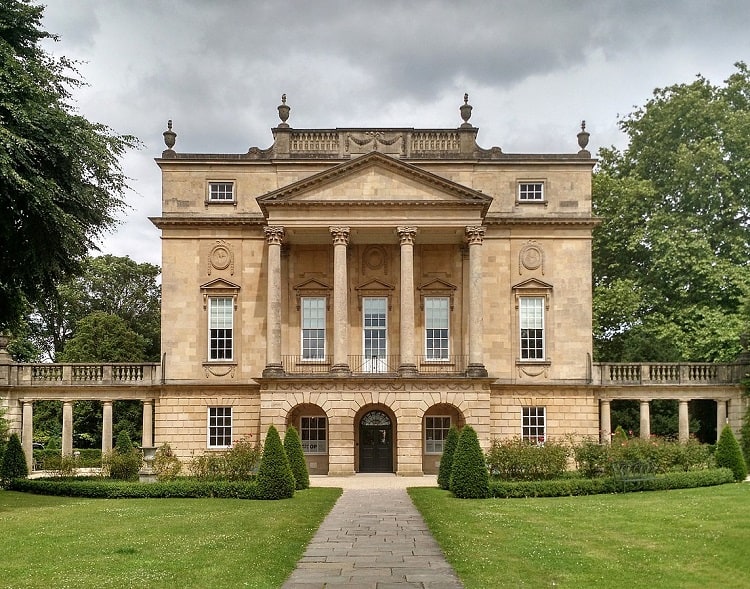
[329,227,351,376]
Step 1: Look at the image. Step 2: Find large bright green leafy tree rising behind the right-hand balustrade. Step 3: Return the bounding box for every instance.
[593,63,750,361]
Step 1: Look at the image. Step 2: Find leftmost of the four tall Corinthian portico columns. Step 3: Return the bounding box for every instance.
[263,226,284,377]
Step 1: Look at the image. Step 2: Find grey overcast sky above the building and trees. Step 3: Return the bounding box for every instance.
[43,0,750,264]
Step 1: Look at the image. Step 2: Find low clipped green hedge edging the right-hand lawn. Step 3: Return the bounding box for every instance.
[490,468,734,499]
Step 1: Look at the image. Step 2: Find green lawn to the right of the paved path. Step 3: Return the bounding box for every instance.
[409,483,750,589]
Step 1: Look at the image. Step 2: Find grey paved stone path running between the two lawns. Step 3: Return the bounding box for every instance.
[282,482,463,589]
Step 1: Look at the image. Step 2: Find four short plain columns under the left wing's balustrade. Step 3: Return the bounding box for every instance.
[21,399,154,470]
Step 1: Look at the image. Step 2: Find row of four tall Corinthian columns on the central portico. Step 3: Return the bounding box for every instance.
[263,226,487,377]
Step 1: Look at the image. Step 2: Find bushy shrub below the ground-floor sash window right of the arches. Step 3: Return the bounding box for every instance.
[487,439,569,481]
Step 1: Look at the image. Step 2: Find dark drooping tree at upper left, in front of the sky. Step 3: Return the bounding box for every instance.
[0,0,136,329]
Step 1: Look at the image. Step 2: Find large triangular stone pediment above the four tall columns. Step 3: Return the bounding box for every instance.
[257,152,492,215]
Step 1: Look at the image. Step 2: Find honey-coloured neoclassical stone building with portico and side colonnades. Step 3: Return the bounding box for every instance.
[0,97,744,475]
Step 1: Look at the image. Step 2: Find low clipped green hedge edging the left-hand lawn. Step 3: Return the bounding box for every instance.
[8,478,260,499]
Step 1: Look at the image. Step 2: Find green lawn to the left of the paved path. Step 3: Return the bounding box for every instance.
[0,488,341,589]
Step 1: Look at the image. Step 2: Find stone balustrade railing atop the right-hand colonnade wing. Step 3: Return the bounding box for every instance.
[592,362,743,386]
